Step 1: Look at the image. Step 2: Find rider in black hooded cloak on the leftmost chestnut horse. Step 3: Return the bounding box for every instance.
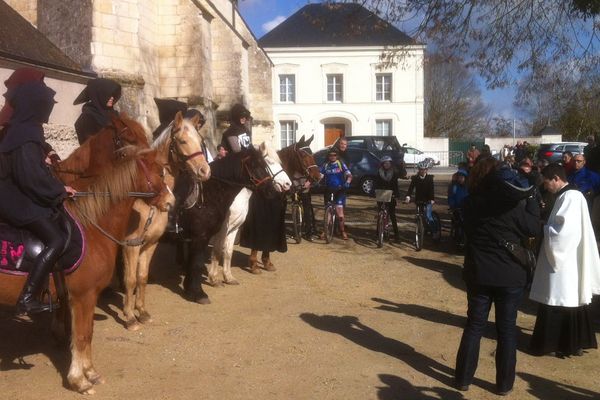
[0,82,75,313]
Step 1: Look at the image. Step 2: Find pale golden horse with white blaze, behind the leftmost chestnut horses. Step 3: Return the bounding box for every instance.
[122,112,210,331]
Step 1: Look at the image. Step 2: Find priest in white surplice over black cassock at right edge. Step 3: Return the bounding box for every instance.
[530,164,600,357]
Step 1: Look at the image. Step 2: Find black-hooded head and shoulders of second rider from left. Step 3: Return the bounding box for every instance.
[73,78,121,144]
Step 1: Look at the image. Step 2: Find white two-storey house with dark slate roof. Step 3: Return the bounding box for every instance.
[258,3,425,149]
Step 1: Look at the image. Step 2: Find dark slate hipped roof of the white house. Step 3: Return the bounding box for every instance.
[258,3,417,48]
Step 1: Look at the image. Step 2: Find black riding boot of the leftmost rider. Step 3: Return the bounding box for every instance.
[17,249,55,314]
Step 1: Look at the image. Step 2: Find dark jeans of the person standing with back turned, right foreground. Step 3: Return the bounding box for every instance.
[455,284,523,391]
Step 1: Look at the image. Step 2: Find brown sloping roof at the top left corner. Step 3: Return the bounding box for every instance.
[0,0,89,75]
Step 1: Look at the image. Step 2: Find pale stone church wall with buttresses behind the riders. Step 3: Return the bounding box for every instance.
[2,0,273,155]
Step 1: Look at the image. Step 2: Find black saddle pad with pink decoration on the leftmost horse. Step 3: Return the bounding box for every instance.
[0,209,86,275]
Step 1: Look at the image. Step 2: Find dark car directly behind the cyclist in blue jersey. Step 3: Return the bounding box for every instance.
[314,147,380,195]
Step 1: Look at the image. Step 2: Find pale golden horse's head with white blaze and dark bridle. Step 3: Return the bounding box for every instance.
[153,112,210,181]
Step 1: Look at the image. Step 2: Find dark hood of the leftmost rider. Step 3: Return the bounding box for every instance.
[0,82,56,152]
